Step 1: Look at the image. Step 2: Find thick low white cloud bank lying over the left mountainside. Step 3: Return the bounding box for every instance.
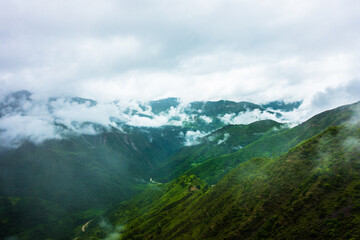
[0,97,197,147]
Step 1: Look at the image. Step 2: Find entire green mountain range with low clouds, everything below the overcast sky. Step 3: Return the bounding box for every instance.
[0,91,360,239]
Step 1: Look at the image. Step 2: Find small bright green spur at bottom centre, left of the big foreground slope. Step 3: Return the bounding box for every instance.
[78,175,209,240]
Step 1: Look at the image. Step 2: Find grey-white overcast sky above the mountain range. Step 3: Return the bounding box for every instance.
[0,0,360,109]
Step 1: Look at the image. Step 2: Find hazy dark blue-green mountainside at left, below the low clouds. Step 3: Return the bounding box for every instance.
[0,127,182,239]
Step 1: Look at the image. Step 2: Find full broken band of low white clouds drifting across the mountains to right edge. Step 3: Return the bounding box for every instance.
[0,89,357,147]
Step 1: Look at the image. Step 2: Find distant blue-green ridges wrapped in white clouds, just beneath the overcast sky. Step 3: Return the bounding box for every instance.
[0,91,302,148]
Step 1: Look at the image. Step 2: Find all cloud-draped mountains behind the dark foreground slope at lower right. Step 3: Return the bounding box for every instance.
[0,91,359,239]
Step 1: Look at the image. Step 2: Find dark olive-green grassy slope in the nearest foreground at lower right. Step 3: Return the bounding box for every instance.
[115,124,360,239]
